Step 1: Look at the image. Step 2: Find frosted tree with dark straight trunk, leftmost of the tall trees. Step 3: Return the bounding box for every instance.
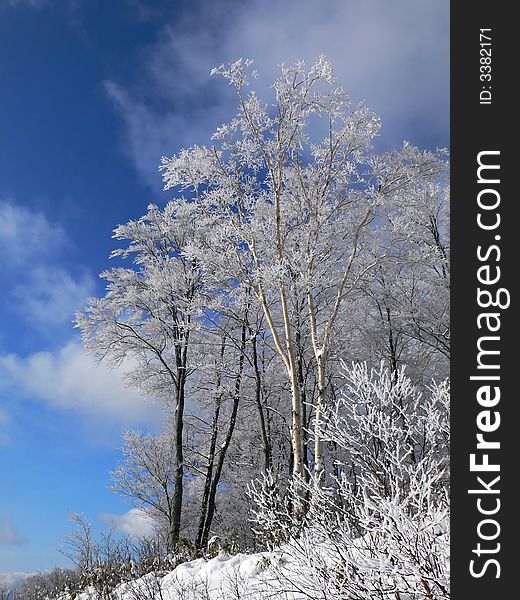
[76,200,204,546]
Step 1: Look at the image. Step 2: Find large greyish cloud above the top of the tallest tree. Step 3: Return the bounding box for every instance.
[106,0,449,187]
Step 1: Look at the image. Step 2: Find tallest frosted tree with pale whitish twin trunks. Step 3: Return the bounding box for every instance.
[162,58,444,488]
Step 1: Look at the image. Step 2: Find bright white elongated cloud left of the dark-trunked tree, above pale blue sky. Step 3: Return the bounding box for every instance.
[0,341,162,425]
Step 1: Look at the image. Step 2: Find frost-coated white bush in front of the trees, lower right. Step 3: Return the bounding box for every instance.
[251,364,449,600]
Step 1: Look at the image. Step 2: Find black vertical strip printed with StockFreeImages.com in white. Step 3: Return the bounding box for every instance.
[451,0,520,600]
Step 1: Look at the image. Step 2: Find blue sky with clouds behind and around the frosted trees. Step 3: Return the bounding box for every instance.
[0,0,449,573]
